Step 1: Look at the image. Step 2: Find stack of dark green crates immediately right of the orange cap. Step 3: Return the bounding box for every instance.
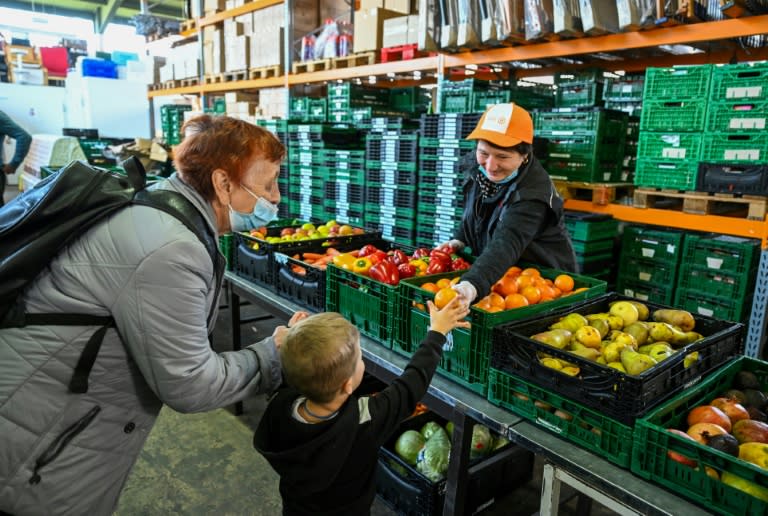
[533,108,628,183]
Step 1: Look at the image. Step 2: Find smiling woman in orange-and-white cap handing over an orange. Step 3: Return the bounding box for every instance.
[443,103,576,303]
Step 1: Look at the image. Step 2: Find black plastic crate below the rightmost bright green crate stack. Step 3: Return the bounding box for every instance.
[696,162,768,195]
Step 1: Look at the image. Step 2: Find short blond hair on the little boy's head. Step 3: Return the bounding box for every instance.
[280,312,360,403]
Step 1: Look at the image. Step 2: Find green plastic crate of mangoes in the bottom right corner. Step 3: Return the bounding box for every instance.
[632,357,768,515]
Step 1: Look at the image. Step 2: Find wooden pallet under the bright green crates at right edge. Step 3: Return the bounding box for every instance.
[633,188,768,220]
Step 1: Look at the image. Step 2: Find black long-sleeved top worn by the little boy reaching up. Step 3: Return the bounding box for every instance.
[253,331,445,516]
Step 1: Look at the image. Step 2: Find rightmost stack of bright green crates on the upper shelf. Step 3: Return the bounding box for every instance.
[700,61,768,187]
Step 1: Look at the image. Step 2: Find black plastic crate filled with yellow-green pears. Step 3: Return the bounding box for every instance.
[491,293,744,424]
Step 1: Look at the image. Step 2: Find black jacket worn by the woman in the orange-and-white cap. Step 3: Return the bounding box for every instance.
[455,152,577,298]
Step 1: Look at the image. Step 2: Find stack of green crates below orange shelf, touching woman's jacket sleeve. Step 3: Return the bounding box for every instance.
[565,211,619,285]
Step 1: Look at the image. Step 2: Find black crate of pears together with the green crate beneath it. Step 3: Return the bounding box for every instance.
[488,293,743,468]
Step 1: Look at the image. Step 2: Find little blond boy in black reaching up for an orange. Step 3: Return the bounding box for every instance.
[253,298,469,516]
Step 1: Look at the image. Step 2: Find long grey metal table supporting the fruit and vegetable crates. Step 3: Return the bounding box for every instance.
[225,271,708,516]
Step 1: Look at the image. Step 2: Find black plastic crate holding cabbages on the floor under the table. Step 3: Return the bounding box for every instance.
[376,412,534,516]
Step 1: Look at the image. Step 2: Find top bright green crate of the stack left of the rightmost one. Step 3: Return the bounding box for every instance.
[643,64,712,100]
